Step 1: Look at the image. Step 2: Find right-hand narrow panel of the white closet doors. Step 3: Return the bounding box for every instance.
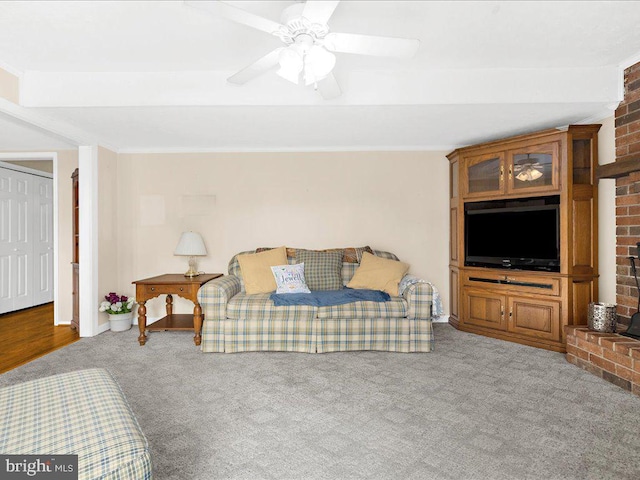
[32,176,53,305]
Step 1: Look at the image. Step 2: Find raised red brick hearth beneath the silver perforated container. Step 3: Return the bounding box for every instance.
[564,326,640,396]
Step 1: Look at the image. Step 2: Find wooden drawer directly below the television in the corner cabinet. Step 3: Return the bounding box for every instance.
[463,271,560,297]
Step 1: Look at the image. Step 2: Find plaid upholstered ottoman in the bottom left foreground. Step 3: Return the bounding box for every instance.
[0,368,153,480]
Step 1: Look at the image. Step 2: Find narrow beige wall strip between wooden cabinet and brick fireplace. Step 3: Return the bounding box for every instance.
[598,116,616,303]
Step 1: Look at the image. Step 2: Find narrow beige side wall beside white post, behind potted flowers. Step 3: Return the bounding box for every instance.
[96,147,119,325]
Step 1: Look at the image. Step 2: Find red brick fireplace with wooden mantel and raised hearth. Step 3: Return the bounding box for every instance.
[565,63,640,395]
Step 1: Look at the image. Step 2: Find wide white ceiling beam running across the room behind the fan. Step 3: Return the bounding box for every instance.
[21,67,620,107]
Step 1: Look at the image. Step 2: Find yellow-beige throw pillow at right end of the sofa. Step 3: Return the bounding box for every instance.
[347,252,409,297]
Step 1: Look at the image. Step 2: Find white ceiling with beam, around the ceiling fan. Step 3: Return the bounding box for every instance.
[0,0,640,151]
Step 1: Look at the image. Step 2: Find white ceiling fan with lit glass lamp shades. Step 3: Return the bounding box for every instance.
[185,0,420,99]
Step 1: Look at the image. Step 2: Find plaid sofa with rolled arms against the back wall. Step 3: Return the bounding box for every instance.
[198,249,434,353]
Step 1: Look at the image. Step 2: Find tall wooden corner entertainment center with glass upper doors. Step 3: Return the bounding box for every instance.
[447,125,600,352]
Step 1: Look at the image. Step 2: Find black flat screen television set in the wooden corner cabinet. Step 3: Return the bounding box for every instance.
[465,196,560,272]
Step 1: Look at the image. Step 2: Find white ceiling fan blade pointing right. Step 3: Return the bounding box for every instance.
[324,33,420,58]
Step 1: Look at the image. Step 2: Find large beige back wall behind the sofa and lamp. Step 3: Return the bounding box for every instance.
[117,152,449,318]
